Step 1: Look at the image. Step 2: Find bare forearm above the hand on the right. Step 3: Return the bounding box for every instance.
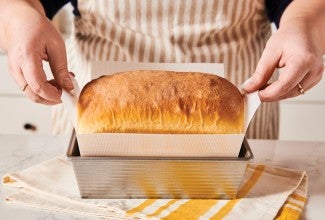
[280,0,325,54]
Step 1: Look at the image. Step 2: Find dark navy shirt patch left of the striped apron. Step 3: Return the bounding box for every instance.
[41,0,80,19]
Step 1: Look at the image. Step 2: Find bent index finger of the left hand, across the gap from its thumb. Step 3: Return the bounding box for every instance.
[21,54,61,103]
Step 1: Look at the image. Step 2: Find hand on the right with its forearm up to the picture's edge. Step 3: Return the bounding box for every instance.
[243,0,325,102]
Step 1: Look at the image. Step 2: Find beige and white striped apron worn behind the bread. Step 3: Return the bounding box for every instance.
[53,0,279,139]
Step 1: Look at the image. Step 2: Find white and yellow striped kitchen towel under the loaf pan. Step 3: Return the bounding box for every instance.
[3,157,307,220]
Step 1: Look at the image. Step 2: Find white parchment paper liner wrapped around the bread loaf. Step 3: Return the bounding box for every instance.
[62,62,260,157]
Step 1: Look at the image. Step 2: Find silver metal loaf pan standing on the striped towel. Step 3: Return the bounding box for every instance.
[67,131,254,199]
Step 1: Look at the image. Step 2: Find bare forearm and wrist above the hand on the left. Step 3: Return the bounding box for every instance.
[0,0,45,50]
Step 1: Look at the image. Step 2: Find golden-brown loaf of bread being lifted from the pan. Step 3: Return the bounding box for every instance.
[77,70,244,134]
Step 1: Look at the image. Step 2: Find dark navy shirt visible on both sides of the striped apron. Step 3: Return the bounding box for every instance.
[41,0,292,27]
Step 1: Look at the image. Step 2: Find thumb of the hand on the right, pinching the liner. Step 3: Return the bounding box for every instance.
[243,44,281,93]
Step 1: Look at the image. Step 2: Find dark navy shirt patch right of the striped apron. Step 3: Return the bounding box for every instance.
[265,0,292,28]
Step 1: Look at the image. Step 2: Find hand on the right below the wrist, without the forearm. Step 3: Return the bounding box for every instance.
[243,19,324,102]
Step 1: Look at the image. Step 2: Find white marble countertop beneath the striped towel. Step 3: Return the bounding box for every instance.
[0,135,325,220]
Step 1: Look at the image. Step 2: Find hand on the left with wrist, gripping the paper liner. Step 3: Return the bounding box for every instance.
[0,0,73,105]
